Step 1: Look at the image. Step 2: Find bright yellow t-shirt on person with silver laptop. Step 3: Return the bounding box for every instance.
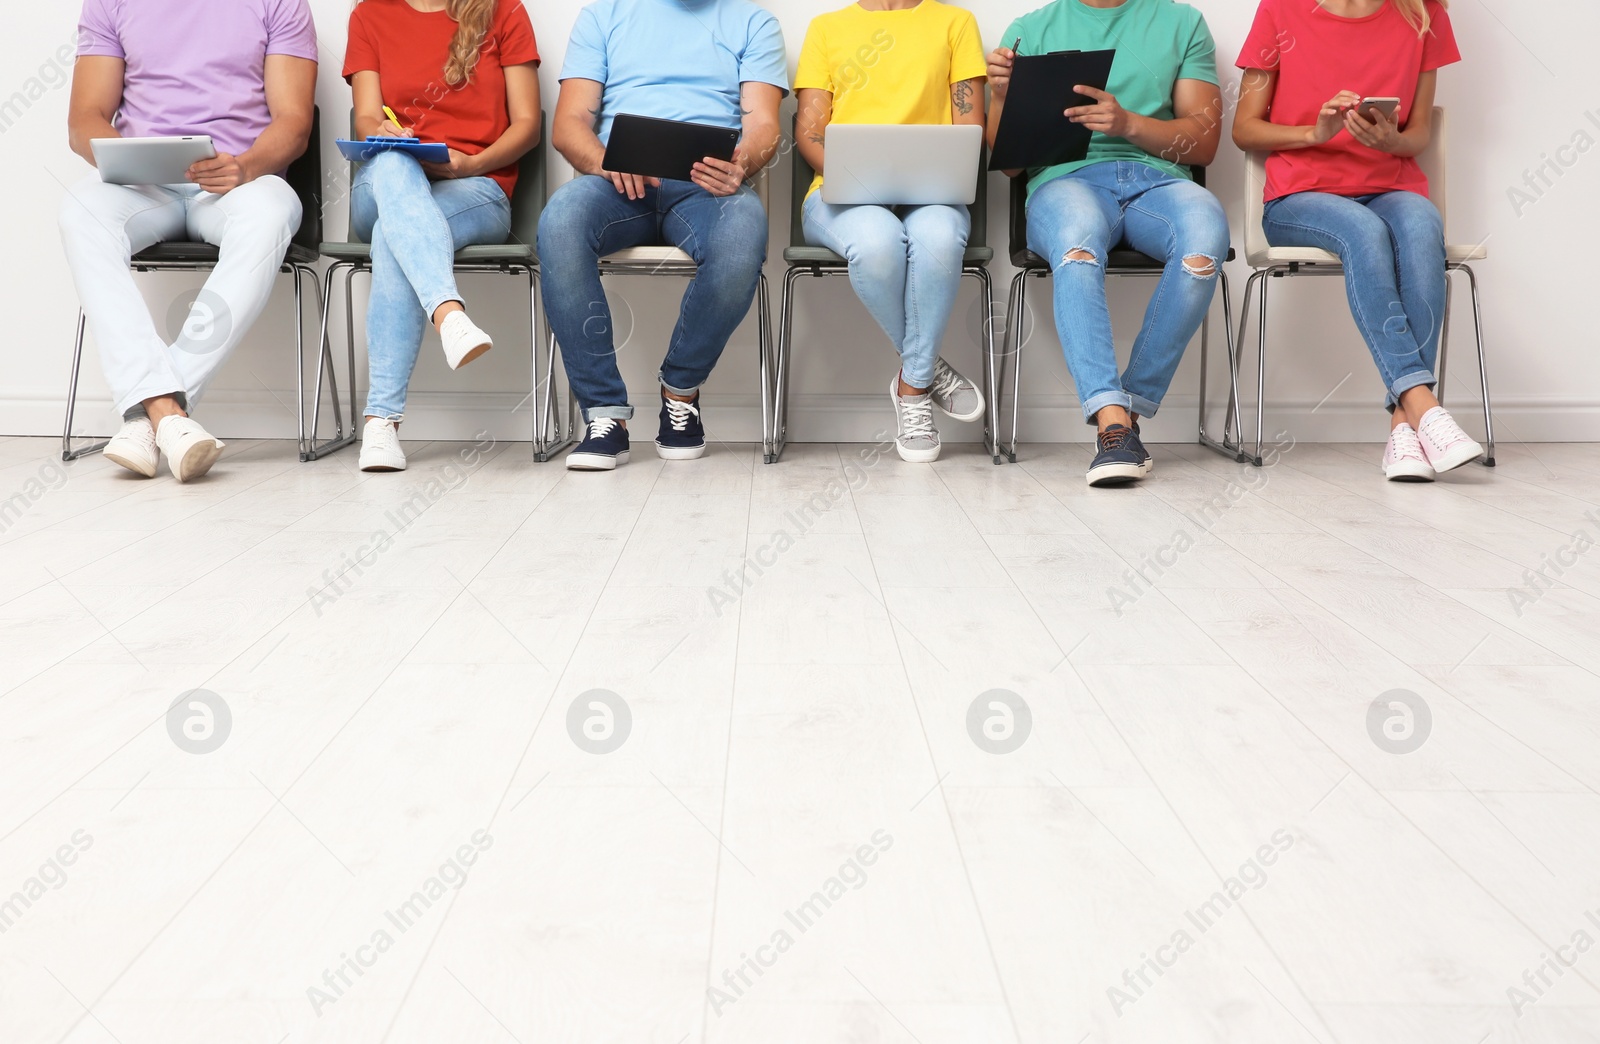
[795,0,987,192]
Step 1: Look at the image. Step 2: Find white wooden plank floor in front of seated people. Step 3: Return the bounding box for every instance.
[0,439,1600,1044]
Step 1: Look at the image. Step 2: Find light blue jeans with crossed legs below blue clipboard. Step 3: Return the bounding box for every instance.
[350,152,510,420]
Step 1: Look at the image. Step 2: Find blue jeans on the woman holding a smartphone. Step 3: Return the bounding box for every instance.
[1261,192,1445,410]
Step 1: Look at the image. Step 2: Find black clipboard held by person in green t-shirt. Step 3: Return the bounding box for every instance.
[989,50,1117,170]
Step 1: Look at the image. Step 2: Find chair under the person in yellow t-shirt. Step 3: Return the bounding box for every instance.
[766,132,1000,464]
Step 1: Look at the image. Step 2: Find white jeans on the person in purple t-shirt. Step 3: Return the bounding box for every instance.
[61,175,301,415]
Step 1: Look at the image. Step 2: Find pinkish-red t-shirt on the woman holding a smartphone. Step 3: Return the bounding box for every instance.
[1237,0,1461,200]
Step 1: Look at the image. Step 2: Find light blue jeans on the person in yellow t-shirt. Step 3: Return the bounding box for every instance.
[802,192,973,387]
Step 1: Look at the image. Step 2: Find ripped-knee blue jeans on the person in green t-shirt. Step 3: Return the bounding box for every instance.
[1027,160,1227,421]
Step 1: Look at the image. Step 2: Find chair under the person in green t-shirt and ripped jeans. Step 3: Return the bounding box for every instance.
[995,167,1245,464]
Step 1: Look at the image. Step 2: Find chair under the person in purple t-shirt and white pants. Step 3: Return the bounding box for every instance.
[61,107,333,461]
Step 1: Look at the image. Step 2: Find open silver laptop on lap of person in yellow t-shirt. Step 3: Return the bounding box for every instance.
[822,123,984,207]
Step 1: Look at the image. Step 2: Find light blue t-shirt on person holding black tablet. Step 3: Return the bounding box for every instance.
[562,0,789,143]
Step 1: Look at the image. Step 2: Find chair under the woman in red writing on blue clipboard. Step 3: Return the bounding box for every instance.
[312,110,549,461]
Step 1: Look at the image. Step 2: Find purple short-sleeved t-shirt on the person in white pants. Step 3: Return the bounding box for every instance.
[78,0,317,155]
